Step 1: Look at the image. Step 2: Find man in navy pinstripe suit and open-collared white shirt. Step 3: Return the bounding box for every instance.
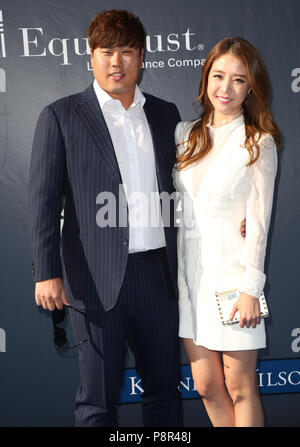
[29,10,181,426]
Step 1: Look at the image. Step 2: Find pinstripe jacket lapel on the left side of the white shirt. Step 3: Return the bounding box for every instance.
[76,85,122,183]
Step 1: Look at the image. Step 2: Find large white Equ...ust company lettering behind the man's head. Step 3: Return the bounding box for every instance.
[15,28,205,71]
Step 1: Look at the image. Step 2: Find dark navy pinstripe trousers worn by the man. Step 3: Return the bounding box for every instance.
[71,248,182,427]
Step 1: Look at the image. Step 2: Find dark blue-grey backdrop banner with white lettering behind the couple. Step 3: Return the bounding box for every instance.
[0,0,300,427]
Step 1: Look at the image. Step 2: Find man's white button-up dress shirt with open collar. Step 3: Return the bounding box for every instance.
[93,79,166,253]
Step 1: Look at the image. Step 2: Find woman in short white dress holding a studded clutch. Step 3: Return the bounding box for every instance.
[173,38,280,427]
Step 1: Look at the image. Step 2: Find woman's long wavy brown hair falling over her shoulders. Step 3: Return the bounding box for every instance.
[177,37,281,170]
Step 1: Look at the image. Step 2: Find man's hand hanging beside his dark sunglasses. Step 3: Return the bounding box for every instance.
[35,278,70,310]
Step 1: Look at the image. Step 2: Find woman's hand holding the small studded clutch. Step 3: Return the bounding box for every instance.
[229,293,260,328]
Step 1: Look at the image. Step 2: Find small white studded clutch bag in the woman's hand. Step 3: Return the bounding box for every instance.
[216,289,269,326]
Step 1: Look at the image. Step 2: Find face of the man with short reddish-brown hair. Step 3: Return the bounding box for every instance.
[91,46,143,109]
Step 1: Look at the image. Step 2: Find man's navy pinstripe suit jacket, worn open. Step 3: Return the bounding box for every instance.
[29,85,180,310]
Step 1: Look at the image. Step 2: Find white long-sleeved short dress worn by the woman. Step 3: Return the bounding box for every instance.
[173,115,277,351]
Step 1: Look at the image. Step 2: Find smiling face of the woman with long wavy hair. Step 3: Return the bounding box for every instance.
[207,53,250,124]
